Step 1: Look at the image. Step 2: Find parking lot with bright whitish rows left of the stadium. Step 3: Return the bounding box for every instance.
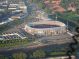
[0,29,26,40]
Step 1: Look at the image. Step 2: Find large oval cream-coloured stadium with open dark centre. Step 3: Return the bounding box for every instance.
[24,20,66,36]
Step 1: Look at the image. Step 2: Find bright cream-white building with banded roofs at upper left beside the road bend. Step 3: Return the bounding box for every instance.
[8,2,27,13]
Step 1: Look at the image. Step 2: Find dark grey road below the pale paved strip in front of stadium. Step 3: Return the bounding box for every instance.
[0,44,67,56]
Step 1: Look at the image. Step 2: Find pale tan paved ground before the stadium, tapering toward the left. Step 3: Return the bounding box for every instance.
[0,34,72,51]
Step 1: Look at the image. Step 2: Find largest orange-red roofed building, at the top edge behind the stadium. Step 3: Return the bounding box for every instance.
[44,0,66,13]
